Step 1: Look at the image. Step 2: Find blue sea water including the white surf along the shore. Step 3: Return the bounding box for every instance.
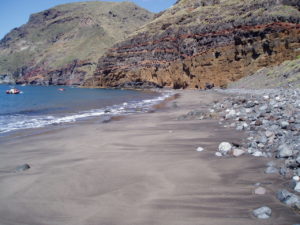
[0,85,170,135]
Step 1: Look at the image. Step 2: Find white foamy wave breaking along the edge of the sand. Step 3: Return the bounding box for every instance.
[0,91,172,133]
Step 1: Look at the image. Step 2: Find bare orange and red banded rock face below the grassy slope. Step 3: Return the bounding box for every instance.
[89,22,300,88]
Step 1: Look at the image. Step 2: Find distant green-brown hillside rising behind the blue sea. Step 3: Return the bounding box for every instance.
[0,2,153,84]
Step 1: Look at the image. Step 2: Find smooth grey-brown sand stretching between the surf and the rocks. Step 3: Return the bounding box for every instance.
[0,91,300,225]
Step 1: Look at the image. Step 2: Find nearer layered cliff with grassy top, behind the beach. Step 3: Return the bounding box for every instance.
[85,0,300,88]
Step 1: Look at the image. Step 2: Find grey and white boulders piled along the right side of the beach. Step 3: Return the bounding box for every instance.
[210,89,300,212]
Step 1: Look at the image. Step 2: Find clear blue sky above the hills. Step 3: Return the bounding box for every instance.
[0,0,176,39]
